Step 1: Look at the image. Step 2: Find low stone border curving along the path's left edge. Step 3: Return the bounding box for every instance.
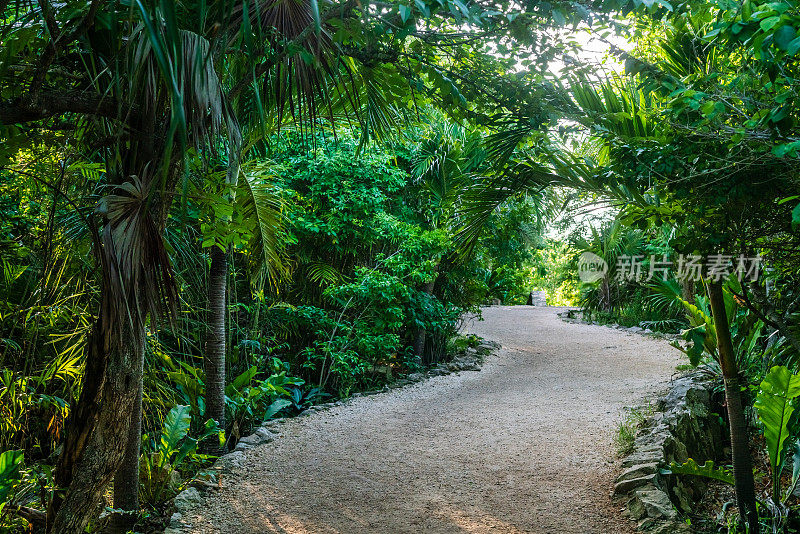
[164,340,500,534]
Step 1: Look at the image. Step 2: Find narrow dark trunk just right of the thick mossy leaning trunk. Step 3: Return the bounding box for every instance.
[105,350,144,534]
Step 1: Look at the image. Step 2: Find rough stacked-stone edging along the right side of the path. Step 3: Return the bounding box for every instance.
[614,372,725,534]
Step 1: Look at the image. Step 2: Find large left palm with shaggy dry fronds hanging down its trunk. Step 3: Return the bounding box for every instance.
[48,11,237,532]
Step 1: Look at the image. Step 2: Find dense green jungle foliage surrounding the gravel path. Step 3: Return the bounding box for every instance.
[0,0,800,534]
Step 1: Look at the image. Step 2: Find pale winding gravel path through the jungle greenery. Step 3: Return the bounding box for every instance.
[184,306,678,534]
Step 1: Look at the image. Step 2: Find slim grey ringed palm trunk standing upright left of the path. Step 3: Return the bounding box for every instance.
[203,245,228,453]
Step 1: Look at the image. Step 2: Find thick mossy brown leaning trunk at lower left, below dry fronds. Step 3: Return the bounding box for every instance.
[47,316,144,534]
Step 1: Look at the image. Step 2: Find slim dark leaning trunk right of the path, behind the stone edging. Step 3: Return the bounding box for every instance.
[708,282,759,534]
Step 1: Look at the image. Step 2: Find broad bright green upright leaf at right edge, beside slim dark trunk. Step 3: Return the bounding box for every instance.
[755,365,800,500]
